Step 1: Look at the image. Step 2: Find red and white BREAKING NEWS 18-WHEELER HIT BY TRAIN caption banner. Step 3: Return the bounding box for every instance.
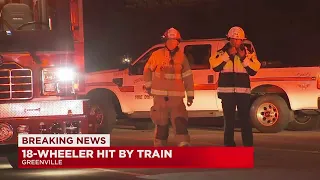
[18,134,254,168]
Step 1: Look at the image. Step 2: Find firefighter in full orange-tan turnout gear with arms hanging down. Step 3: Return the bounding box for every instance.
[144,28,194,147]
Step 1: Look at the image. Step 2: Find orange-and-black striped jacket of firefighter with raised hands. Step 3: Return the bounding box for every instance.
[209,43,261,96]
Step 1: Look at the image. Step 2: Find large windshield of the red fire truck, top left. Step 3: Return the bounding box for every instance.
[0,0,73,52]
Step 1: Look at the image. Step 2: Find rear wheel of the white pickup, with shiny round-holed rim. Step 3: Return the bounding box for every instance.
[250,95,290,133]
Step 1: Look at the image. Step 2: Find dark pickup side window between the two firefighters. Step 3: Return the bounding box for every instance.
[184,44,211,70]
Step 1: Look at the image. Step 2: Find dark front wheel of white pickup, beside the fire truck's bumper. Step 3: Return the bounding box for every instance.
[90,98,117,134]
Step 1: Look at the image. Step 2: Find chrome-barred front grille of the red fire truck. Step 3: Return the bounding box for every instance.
[0,63,33,101]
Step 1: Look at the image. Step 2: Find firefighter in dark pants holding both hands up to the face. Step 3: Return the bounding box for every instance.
[209,27,261,146]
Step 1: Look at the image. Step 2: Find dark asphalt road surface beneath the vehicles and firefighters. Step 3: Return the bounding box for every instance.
[0,126,320,180]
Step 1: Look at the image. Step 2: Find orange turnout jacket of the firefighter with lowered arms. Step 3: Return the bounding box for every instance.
[143,48,194,98]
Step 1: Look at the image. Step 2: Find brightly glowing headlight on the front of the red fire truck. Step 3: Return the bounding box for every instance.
[42,67,79,95]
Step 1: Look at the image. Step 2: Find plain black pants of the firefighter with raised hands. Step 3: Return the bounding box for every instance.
[221,93,253,146]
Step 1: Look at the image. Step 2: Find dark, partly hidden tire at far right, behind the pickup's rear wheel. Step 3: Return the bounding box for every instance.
[287,114,320,131]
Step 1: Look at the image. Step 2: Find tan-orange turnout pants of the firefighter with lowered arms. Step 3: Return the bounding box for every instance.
[150,96,190,147]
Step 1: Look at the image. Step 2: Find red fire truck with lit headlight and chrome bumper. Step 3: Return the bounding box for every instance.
[0,0,97,167]
